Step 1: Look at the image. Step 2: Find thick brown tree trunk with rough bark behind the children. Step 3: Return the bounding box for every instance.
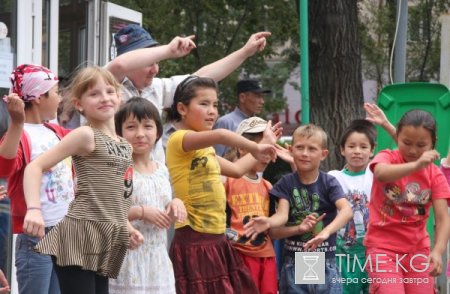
[309,0,364,171]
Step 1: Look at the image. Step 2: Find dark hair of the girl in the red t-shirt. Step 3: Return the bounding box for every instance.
[397,109,437,149]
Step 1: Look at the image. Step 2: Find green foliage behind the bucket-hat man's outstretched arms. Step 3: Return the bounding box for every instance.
[110,0,299,112]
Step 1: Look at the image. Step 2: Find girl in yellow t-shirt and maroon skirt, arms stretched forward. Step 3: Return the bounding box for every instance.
[166,76,276,294]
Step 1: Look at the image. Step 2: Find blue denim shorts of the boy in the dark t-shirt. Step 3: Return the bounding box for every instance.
[280,256,342,294]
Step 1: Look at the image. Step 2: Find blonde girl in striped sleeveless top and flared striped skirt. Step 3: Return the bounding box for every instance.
[24,67,143,294]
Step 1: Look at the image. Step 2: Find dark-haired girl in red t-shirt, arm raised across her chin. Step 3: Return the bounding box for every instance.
[361,110,450,293]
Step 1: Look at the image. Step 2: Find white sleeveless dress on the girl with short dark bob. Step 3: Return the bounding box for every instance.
[109,164,175,294]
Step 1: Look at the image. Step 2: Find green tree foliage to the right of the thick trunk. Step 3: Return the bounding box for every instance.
[358,0,450,89]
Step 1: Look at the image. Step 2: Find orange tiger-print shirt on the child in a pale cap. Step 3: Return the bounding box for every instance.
[225,176,275,257]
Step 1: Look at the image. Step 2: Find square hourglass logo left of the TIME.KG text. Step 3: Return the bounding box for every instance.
[295,252,325,284]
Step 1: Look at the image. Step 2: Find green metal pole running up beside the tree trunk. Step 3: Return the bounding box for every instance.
[299,0,309,124]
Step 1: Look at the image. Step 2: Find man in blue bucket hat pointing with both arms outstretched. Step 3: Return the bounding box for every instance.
[106,24,270,163]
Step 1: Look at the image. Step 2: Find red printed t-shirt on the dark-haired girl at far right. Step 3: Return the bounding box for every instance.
[364,150,450,253]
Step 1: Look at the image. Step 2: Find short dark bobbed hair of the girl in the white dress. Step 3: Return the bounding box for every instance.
[114,97,163,142]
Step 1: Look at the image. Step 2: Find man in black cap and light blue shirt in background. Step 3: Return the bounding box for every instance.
[214,79,272,156]
